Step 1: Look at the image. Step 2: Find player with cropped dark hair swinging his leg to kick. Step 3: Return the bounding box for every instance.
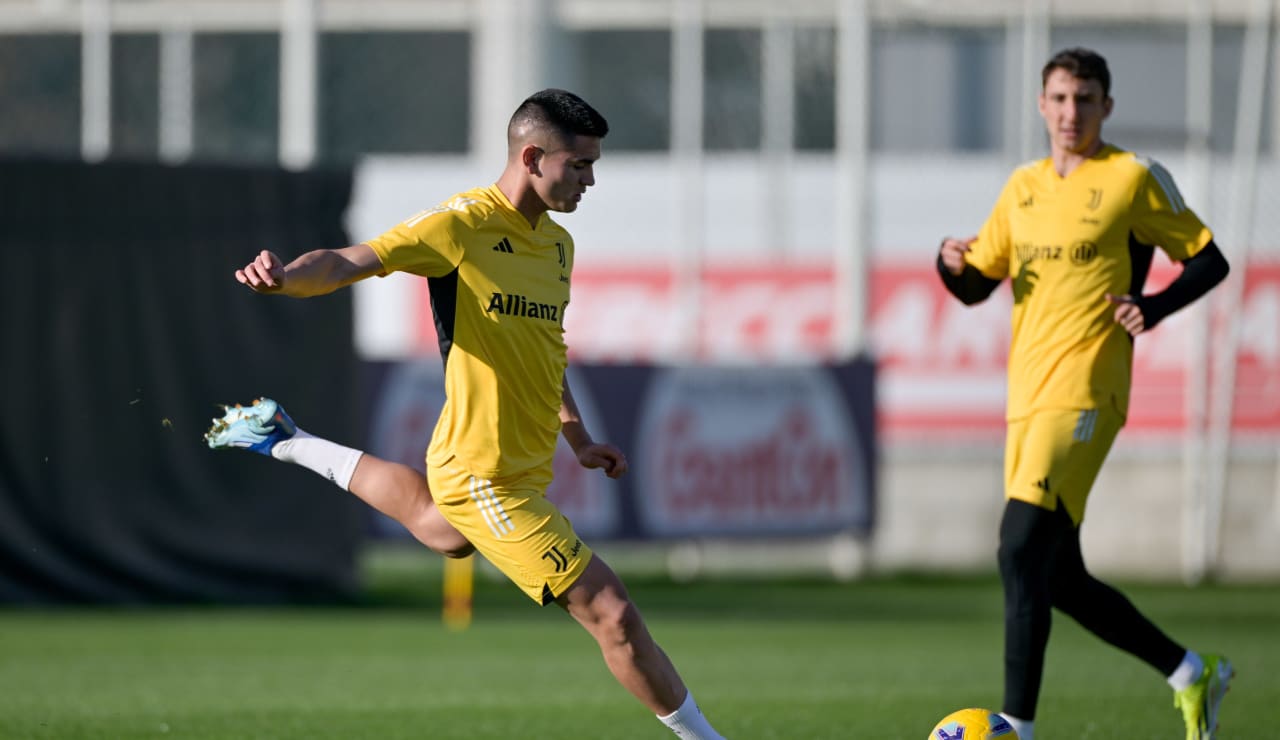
[206,90,721,740]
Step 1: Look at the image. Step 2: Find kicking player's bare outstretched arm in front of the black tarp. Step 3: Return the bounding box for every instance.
[236,245,383,298]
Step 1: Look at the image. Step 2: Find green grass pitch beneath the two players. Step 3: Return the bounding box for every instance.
[0,557,1280,740]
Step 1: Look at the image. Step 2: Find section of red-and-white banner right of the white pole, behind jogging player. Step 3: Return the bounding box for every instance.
[870,261,1280,438]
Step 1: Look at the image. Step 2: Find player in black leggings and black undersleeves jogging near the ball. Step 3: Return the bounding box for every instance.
[937,49,1233,740]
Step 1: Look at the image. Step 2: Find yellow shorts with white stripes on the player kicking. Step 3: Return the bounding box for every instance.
[426,458,591,606]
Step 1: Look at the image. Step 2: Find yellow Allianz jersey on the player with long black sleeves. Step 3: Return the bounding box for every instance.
[966,146,1213,419]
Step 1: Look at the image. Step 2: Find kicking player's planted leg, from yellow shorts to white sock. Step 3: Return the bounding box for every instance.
[556,554,722,740]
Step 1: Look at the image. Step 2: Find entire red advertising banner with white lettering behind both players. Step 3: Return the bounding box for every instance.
[401,257,1280,440]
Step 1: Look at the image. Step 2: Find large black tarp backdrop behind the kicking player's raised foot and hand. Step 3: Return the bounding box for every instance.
[0,161,365,604]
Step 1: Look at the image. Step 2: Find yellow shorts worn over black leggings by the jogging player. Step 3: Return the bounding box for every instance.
[1005,407,1124,526]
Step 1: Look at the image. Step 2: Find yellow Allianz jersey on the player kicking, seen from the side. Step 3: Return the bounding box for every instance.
[369,186,573,478]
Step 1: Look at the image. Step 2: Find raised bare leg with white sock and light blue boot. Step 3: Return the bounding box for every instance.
[205,398,475,557]
